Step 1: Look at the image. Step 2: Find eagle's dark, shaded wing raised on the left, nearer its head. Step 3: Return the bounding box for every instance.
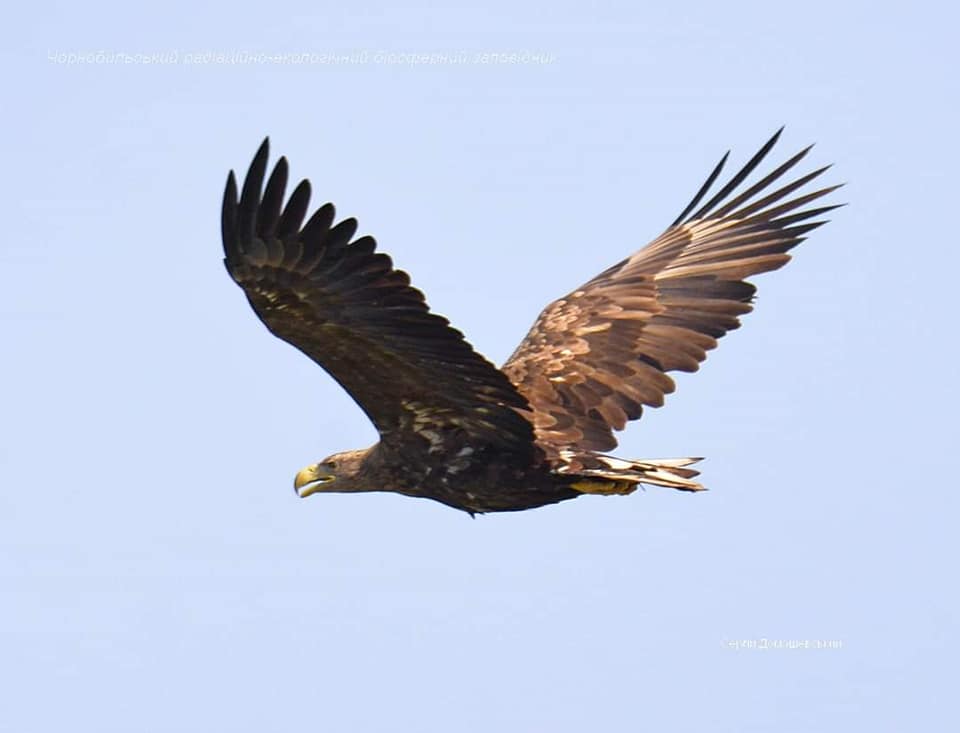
[222,140,534,455]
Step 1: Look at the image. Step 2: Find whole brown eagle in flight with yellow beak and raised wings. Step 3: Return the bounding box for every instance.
[221,128,839,515]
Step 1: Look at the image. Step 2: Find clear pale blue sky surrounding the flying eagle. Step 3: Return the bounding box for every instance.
[0,2,960,733]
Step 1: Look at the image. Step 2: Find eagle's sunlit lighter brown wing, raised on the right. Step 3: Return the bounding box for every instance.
[503,128,839,451]
